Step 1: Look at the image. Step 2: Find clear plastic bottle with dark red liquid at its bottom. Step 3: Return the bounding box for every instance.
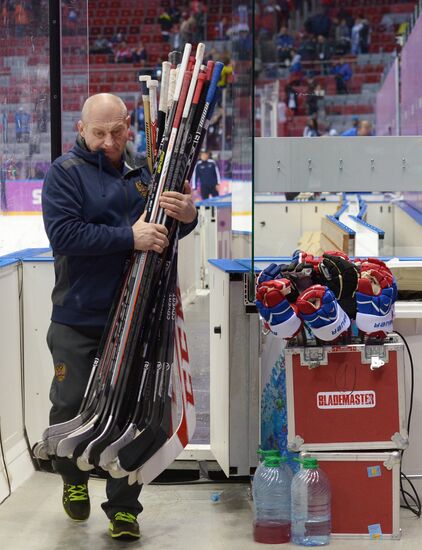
[252,457,293,544]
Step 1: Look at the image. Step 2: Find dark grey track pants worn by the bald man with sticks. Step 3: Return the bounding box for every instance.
[47,322,142,518]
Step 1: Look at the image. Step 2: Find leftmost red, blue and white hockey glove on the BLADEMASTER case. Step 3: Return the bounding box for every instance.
[255,279,302,338]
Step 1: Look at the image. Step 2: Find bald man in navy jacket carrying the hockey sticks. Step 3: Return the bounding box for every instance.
[42,94,197,538]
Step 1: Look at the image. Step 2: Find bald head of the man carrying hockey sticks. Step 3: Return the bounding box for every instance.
[78,94,130,163]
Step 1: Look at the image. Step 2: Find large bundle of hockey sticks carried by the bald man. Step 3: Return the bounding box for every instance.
[34,44,223,483]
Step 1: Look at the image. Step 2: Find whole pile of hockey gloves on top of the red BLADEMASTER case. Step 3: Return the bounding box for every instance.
[255,251,397,342]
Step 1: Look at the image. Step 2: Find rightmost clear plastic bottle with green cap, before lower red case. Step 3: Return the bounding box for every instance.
[292,458,331,546]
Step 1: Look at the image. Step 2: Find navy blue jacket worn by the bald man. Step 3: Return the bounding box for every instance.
[42,138,197,327]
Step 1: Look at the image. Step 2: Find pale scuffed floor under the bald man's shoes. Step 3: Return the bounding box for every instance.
[0,472,422,550]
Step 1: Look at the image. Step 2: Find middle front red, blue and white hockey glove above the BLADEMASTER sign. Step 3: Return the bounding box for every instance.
[296,285,350,342]
